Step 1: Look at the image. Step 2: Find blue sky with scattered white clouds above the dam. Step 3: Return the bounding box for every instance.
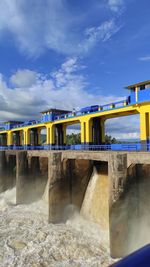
[0,0,150,138]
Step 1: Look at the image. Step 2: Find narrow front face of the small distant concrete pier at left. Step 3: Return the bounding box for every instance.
[16,151,29,204]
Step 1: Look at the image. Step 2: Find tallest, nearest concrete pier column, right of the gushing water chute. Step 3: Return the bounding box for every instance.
[109,153,128,258]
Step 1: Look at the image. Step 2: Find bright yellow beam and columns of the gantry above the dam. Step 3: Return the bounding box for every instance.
[0,102,150,146]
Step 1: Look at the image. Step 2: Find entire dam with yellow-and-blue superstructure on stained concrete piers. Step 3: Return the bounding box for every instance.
[0,81,150,258]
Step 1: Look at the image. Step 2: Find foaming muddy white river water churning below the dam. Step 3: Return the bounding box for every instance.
[0,188,112,267]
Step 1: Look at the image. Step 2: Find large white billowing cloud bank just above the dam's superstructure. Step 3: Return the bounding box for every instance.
[0,58,120,120]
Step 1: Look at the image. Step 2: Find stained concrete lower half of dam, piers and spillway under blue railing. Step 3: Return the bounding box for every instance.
[0,150,150,257]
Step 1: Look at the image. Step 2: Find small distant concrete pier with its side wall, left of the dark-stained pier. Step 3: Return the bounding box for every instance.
[16,151,48,204]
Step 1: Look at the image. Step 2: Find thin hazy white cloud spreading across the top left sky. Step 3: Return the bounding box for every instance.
[0,0,121,57]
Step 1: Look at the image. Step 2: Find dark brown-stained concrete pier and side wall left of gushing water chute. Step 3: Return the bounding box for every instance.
[49,153,92,222]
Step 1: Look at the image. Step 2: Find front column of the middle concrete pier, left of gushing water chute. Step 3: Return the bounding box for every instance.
[48,152,70,223]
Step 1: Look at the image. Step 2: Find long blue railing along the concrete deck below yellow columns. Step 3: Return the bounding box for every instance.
[0,143,150,151]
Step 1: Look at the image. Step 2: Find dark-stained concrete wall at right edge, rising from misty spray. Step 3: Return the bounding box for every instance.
[110,161,150,258]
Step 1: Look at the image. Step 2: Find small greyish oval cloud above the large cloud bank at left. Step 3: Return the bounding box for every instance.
[10,69,37,87]
